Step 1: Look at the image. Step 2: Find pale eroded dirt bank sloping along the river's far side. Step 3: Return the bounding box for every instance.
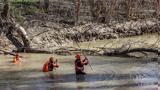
[27,20,159,49]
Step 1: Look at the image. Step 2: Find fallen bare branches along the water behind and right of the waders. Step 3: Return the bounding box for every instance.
[54,47,160,57]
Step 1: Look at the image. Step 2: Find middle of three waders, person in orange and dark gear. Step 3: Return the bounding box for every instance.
[43,57,59,72]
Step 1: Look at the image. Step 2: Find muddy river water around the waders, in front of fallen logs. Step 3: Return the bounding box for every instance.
[0,54,159,90]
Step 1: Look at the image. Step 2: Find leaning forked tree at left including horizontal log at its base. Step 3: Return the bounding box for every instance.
[0,0,52,55]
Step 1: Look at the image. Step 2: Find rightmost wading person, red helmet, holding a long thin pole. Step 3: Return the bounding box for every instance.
[75,54,88,74]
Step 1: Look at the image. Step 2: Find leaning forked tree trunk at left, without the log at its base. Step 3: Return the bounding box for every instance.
[0,0,30,49]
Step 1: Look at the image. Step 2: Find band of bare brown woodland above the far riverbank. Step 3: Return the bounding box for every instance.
[0,0,160,24]
